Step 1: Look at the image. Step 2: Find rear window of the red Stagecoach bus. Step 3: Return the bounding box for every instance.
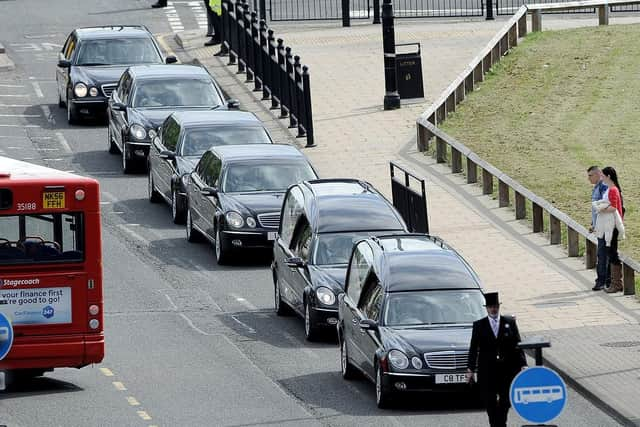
[0,213,84,265]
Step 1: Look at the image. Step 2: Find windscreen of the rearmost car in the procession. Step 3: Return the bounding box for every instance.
[76,38,162,66]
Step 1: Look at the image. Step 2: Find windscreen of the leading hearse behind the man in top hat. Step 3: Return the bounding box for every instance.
[384,289,486,326]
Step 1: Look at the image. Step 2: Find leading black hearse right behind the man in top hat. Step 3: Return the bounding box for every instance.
[338,234,486,408]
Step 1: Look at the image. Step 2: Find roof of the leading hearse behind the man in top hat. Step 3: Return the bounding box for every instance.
[371,234,481,292]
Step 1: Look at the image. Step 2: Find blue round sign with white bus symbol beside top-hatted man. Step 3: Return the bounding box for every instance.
[509,366,567,424]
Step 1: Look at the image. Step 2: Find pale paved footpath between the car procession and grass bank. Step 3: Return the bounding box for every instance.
[168,16,640,425]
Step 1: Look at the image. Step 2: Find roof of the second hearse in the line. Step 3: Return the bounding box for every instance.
[303,179,406,233]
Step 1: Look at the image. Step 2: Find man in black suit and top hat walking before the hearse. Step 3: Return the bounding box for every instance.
[467,292,527,427]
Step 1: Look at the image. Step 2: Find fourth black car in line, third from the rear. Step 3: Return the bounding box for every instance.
[148,111,273,224]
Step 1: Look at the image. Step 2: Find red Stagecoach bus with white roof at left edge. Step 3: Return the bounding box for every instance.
[0,157,104,376]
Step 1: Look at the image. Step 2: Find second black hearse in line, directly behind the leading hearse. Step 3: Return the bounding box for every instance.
[271,179,407,340]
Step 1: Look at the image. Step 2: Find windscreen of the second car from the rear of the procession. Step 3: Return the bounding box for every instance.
[133,78,222,108]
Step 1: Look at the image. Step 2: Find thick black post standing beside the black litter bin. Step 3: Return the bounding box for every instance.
[382,0,400,110]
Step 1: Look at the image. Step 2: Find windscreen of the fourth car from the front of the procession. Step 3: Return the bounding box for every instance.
[181,126,271,156]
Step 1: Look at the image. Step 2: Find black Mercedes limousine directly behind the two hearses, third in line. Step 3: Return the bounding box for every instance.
[187,144,317,264]
